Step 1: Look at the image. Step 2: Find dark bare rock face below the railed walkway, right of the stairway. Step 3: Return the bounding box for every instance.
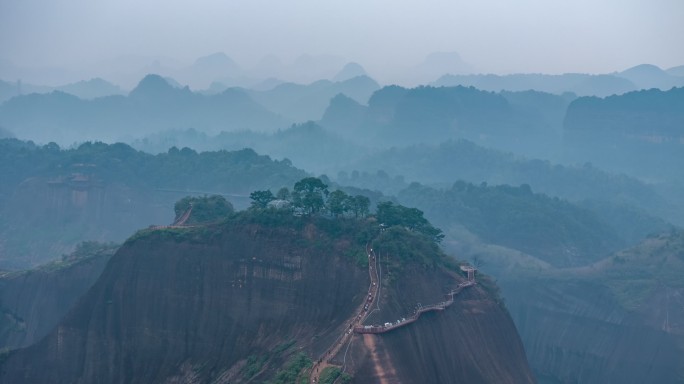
[353,288,535,383]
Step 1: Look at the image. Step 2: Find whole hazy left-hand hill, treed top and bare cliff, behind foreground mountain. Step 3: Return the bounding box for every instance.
[0,139,306,268]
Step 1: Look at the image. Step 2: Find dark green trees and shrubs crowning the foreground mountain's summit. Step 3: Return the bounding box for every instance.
[136,177,453,272]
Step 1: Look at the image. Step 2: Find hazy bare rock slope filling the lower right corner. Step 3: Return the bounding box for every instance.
[504,283,684,383]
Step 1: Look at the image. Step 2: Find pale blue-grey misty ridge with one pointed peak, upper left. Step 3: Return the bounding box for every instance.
[0,75,288,144]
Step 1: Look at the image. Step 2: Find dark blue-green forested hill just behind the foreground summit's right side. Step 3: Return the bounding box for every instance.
[399,182,624,266]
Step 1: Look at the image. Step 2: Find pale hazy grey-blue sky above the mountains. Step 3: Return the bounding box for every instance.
[0,0,684,78]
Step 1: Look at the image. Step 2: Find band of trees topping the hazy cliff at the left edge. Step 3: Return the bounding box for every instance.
[0,139,306,194]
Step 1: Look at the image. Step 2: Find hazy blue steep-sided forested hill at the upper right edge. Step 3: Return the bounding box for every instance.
[564,88,684,183]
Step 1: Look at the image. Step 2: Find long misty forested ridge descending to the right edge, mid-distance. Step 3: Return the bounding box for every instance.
[341,140,684,223]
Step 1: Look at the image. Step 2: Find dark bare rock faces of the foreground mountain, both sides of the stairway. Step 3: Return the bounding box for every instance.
[0,214,533,383]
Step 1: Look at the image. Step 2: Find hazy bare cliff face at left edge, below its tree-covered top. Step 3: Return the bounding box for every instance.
[0,174,174,270]
